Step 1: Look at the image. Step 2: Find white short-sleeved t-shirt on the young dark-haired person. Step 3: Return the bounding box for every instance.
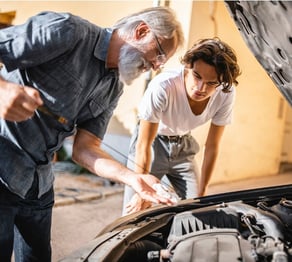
[138,67,235,136]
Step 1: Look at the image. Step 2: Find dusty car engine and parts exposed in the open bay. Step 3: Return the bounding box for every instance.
[120,199,292,262]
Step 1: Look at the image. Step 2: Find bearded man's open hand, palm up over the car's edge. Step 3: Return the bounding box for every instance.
[128,174,176,206]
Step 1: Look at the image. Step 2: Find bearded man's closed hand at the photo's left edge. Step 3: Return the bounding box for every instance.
[0,79,43,122]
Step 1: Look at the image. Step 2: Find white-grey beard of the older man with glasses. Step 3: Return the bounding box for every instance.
[118,44,151,85]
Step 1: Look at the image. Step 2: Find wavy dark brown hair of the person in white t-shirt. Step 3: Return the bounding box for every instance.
[181,37,241,92]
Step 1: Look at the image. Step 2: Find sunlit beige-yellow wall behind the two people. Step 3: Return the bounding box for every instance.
[0,0,287,183]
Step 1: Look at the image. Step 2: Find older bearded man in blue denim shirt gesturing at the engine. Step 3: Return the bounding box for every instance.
[0,7,183,262]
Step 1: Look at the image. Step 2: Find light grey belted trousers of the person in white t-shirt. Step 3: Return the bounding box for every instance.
[123,127,200,214]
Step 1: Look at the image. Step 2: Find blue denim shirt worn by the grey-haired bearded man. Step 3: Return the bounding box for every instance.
[0,12,123,198]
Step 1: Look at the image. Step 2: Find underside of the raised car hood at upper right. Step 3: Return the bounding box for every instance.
[225,1,292,105]
